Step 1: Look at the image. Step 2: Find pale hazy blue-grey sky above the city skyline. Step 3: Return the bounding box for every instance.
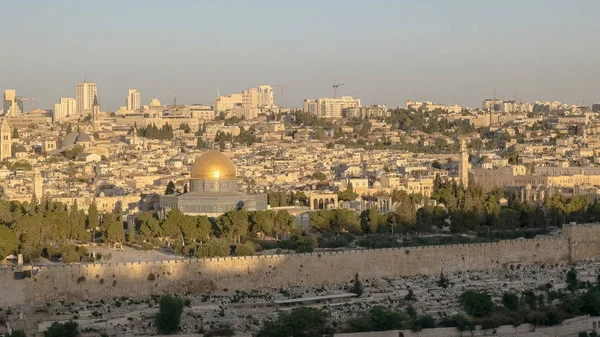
[0,0,600,111]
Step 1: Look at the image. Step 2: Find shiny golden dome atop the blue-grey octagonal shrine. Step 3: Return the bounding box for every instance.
[190,150,235,180]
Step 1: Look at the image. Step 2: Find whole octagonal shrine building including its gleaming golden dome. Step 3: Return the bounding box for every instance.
[155,150,267,216]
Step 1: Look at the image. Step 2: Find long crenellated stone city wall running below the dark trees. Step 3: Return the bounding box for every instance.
[0,225,600,307]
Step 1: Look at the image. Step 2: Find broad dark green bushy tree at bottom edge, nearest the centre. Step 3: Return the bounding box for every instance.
[258,307,328,337]
